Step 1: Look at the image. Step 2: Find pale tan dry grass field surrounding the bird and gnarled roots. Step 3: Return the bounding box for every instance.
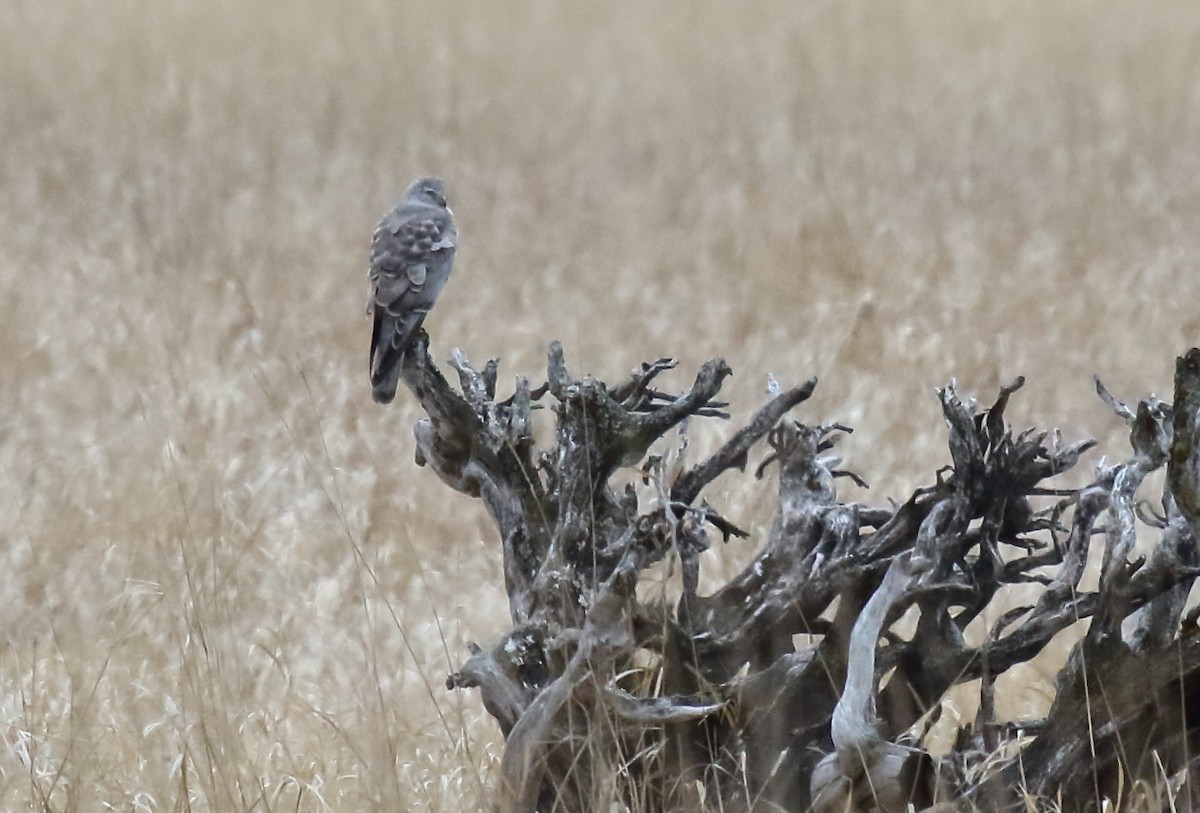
[7,0,1200,812]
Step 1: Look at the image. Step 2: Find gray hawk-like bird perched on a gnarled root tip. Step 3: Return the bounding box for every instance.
[367,177,458,404]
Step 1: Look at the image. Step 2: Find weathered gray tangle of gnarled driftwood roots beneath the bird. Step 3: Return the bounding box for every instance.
[401,335,1200,813]
